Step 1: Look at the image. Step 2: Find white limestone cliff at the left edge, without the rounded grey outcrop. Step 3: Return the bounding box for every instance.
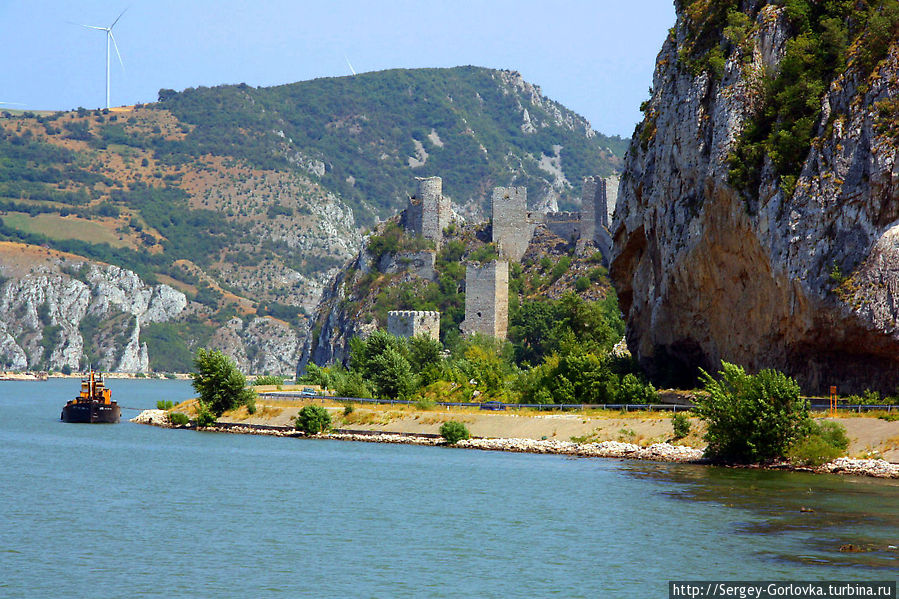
[0,246,187,372]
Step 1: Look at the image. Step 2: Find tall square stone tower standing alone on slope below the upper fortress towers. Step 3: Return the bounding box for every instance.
[460,260,509,340]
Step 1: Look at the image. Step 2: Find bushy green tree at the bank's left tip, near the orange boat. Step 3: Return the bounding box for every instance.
[190,348,256,418]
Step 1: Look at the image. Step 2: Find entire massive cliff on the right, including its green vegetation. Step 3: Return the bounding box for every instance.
[611,0,899,393]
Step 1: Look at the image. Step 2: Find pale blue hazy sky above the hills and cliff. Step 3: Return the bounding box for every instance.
[0,0,674,136]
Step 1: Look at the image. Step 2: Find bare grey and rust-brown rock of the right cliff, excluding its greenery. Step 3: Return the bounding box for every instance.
[611,2,899,392]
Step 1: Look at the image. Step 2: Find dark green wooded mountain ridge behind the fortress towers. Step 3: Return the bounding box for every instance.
[160,67,625,221]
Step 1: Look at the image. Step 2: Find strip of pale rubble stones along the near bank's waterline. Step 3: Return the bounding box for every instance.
[131,410,899,479]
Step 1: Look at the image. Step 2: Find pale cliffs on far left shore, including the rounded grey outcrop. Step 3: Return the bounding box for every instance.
[0,242,302,374]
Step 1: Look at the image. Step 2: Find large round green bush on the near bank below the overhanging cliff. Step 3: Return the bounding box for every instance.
[694,362,808,462]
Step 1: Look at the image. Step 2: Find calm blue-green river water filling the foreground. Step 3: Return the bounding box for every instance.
[0,379,899,598]
